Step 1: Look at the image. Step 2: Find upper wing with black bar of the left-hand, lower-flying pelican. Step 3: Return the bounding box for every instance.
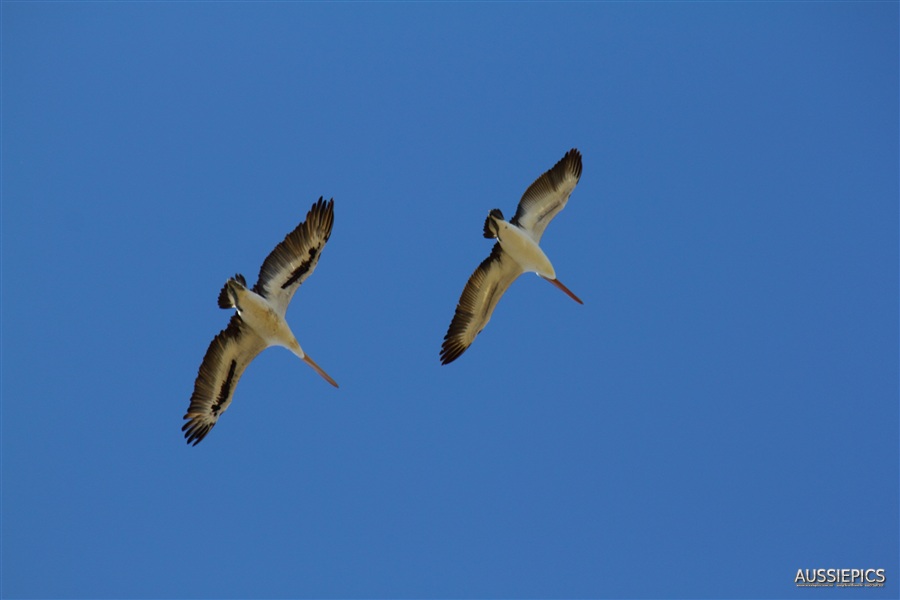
[253,198,334,317]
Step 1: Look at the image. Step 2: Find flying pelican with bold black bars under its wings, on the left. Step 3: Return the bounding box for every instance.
[181,198,338,446]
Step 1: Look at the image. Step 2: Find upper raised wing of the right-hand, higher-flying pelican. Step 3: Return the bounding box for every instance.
[510,148,581,243]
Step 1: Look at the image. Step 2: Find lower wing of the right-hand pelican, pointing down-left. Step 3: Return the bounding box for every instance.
[441,244,524,365]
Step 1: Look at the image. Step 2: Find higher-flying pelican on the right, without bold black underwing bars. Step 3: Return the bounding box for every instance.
[441,148,584,365]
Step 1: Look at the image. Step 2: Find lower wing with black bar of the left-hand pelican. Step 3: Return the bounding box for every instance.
[181,315,266,446]
